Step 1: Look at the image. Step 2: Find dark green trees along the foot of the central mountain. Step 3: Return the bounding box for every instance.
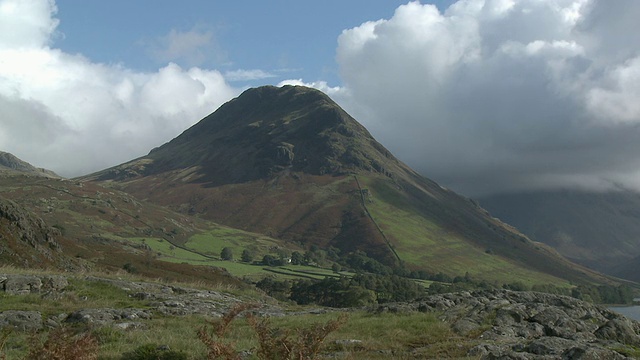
[235,246,634,307]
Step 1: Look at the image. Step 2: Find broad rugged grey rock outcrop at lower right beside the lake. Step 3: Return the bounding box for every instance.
[372,290,640,359]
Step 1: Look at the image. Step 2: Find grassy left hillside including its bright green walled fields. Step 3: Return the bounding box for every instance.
[0,175,308,283]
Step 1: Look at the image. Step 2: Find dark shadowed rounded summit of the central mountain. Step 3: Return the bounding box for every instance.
[101,86,401,185]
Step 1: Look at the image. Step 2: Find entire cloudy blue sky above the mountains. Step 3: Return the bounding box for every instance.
[0,0,640,197]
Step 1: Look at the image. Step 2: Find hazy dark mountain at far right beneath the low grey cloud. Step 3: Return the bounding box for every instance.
[479,189,640,281]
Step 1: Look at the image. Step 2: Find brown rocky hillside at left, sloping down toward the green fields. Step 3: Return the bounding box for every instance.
[0,172,246,287]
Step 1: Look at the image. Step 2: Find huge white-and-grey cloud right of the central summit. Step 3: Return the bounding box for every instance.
[336,0,640,194]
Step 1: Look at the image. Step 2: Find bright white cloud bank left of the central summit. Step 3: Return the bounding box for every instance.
[0,0,239,176]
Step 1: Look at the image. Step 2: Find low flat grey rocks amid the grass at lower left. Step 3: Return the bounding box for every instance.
[0,274,276,331]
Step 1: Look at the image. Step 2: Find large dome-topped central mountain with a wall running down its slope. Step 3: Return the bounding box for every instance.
[78,86,605,283]
